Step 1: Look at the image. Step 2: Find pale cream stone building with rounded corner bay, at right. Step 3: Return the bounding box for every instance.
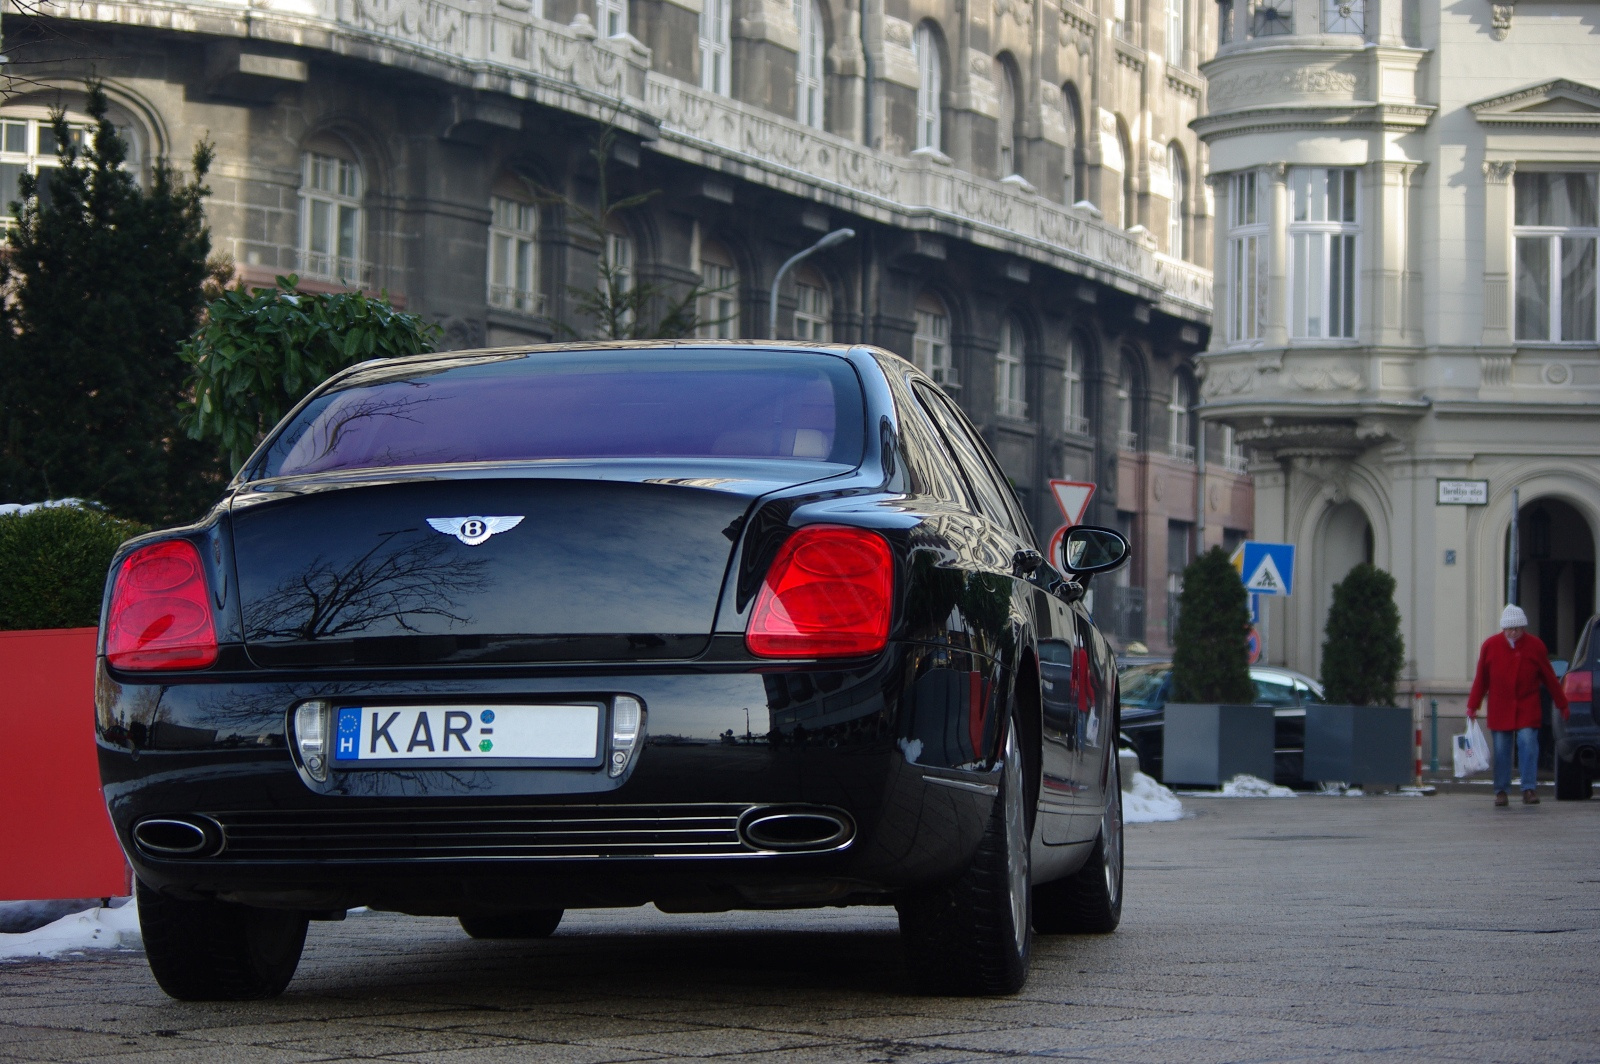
[1194,0,1600,707]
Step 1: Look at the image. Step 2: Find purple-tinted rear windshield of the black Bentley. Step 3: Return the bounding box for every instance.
[250,349,864,480]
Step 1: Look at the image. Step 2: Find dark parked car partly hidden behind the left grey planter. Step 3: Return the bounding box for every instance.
[1118,661,1326,787]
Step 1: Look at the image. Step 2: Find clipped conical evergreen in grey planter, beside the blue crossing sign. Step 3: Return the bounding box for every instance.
[1173,547,1256,704]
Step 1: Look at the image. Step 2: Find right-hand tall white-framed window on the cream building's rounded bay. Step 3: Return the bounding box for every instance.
[1290,166,1360,339]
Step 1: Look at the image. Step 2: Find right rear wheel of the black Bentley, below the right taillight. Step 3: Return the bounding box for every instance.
[896,718,1032,995]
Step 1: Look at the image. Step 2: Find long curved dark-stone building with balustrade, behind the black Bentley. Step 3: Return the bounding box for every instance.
[0,0,1251,645]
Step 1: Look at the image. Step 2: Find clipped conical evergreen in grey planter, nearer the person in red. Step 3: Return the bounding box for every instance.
[1322,563,1405,706]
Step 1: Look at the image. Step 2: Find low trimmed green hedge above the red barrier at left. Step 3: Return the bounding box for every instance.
[0,506,149,632]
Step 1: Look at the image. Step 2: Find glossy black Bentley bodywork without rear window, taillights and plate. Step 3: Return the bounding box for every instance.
[96,344,1117,914]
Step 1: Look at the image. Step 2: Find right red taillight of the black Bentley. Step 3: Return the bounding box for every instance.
[744,525,894,658]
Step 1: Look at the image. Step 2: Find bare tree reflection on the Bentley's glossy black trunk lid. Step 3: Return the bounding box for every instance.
[245,528,488,642]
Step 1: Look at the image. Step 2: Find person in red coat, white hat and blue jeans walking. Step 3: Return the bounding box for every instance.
[1467,606,1571,805]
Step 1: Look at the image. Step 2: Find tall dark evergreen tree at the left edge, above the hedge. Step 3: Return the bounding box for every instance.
[0,83,221,523]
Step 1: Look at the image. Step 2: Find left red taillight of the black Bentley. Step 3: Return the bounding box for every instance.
[106,539,216,669]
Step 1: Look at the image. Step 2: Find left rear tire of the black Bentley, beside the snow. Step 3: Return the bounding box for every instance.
[138,883,307,1002]
